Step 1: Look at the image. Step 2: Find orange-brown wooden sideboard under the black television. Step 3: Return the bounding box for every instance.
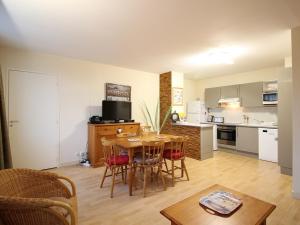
[88,123,140,167]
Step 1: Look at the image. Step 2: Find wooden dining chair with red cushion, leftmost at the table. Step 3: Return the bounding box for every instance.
[100,138,129,198]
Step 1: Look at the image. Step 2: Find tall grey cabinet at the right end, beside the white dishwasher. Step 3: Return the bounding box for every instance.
[278,74,293,175]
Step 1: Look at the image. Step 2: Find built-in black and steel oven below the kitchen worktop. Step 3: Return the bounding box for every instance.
[217,125,236,148]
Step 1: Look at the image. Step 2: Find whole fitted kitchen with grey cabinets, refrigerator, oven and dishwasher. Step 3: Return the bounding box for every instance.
[179,68,292,175]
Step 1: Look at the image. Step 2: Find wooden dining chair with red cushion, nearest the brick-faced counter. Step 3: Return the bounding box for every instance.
[163,137,190,186]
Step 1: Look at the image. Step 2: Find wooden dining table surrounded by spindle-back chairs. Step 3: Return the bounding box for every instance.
[112,133,178,196]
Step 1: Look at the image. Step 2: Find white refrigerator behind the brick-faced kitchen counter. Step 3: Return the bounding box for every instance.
[186,101,207,123]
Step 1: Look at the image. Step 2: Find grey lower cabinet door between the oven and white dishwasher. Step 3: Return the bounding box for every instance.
[236,127,258,154]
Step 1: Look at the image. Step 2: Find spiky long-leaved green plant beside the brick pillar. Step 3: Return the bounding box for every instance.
[141,101,172,132]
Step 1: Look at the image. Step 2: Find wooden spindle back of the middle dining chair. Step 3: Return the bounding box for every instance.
[142,141,165,164]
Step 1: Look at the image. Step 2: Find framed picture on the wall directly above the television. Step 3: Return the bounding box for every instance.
[105,83,131,102]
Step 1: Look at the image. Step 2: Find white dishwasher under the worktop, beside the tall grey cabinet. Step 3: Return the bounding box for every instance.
[258,128,278,162]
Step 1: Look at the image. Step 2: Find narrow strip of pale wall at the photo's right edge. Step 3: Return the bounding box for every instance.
[292,27,300,199]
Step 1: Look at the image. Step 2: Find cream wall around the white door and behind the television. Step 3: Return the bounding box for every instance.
[0,49,159,164]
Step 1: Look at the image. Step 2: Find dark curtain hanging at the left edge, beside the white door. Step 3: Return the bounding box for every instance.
[0,67,12,170]
